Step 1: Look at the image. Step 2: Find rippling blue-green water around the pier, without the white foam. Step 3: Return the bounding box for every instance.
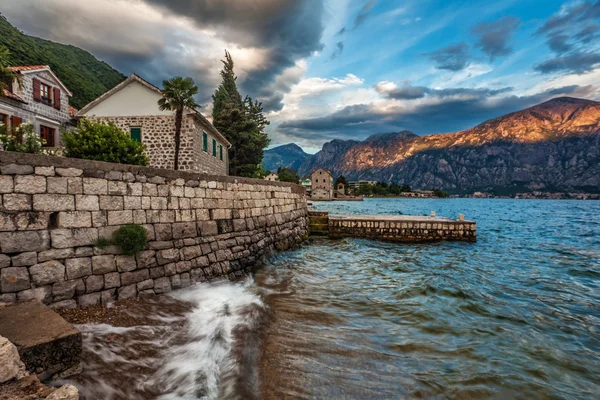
[255,199,600,399]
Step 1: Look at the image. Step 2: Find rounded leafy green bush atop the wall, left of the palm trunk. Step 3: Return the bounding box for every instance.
[62,119,150,165]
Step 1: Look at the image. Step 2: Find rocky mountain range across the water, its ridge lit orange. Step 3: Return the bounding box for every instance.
[298,97,600,194]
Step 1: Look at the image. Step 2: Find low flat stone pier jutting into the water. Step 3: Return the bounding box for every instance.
[326,215,477,242]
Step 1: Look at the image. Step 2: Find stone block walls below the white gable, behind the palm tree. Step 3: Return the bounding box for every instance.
[88,115,229,175]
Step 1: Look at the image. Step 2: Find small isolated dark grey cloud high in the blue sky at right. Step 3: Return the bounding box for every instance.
[472,17,520,61]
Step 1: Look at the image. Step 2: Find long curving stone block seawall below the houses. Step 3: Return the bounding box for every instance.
[0,151,308,307]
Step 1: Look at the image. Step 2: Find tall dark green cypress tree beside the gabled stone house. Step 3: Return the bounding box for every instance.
[213,52,270,177]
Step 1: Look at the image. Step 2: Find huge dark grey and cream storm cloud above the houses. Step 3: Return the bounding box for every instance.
[2,0,323,109]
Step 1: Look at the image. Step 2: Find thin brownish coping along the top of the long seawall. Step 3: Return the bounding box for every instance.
[0,150,305,194]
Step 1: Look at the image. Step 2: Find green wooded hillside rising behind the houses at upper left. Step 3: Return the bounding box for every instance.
[0,16,125,109]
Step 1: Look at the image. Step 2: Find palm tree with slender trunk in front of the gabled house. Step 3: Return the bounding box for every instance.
[158,76,200,169]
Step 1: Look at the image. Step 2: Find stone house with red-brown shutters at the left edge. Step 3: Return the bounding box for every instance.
[0,65,74,147]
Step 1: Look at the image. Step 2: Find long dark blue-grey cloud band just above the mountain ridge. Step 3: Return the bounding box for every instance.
[279,85,598,141]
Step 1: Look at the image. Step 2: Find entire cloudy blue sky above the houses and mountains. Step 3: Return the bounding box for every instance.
[0,0,600,153]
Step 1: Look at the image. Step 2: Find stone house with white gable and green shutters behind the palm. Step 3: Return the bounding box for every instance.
[77,74,231,175]
